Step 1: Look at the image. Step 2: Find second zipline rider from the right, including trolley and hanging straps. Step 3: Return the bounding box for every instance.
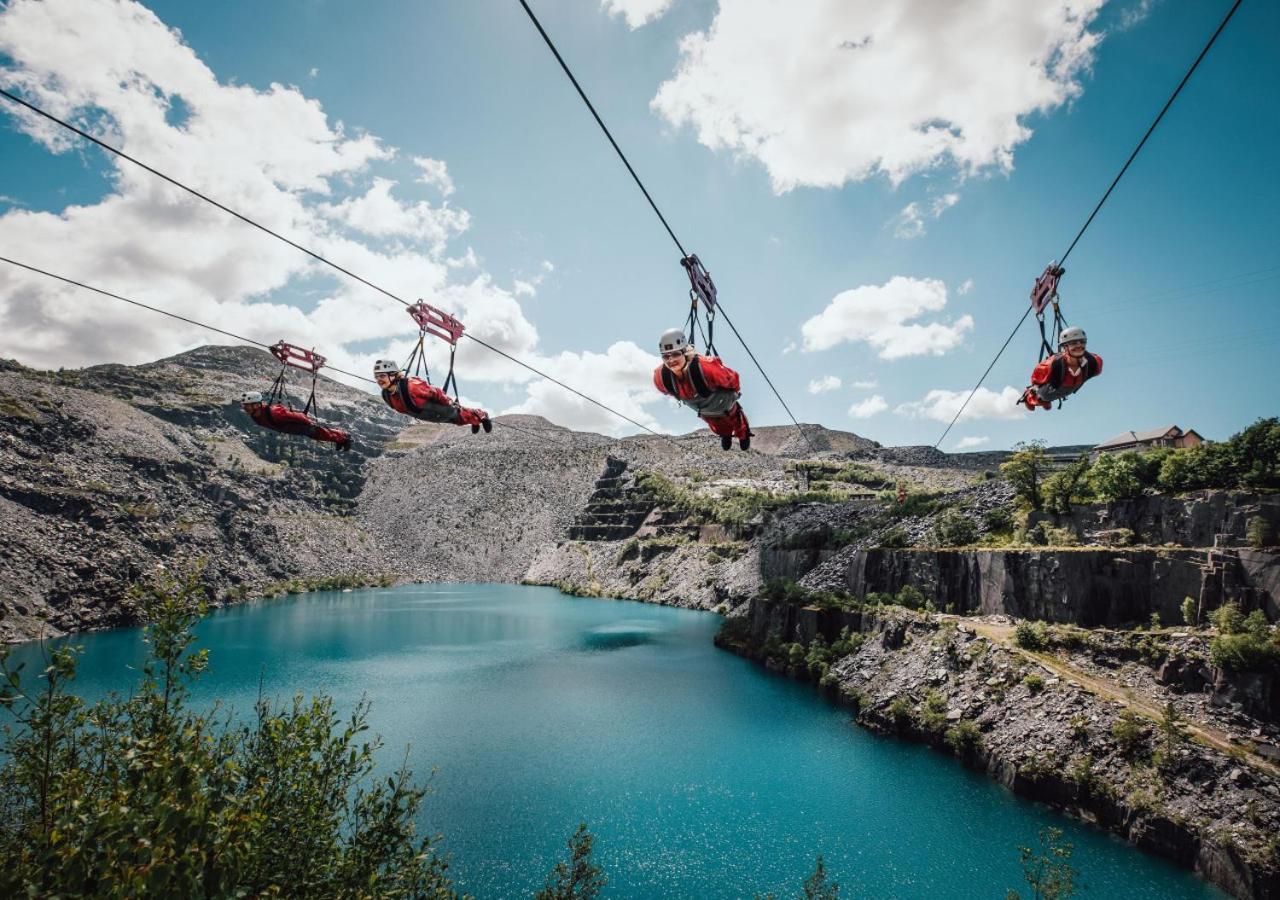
[653,253,755,451]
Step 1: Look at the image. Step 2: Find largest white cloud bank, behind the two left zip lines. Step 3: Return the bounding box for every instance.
[0,0,660,434]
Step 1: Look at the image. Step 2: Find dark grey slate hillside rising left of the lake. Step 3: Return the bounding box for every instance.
[0,347,399,640]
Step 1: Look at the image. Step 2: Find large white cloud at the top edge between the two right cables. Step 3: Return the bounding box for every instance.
[655,0,1103,193]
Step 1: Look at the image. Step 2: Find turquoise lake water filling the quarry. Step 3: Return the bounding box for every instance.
[15,584,1224,900]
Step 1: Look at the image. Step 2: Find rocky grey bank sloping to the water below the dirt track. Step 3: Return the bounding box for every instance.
[717,600,1280,900]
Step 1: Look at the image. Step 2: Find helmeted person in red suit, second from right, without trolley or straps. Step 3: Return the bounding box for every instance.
[653,328,753,449]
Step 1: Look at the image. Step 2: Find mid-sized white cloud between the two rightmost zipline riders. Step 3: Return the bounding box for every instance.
[800,275,973,360]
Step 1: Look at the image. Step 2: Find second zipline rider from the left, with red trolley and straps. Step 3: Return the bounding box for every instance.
[374,301,493,434]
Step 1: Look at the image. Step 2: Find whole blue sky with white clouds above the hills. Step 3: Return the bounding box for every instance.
[0,0,1280,451]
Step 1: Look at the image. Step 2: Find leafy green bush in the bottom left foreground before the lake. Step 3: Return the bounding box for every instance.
[0,576,456,899]
